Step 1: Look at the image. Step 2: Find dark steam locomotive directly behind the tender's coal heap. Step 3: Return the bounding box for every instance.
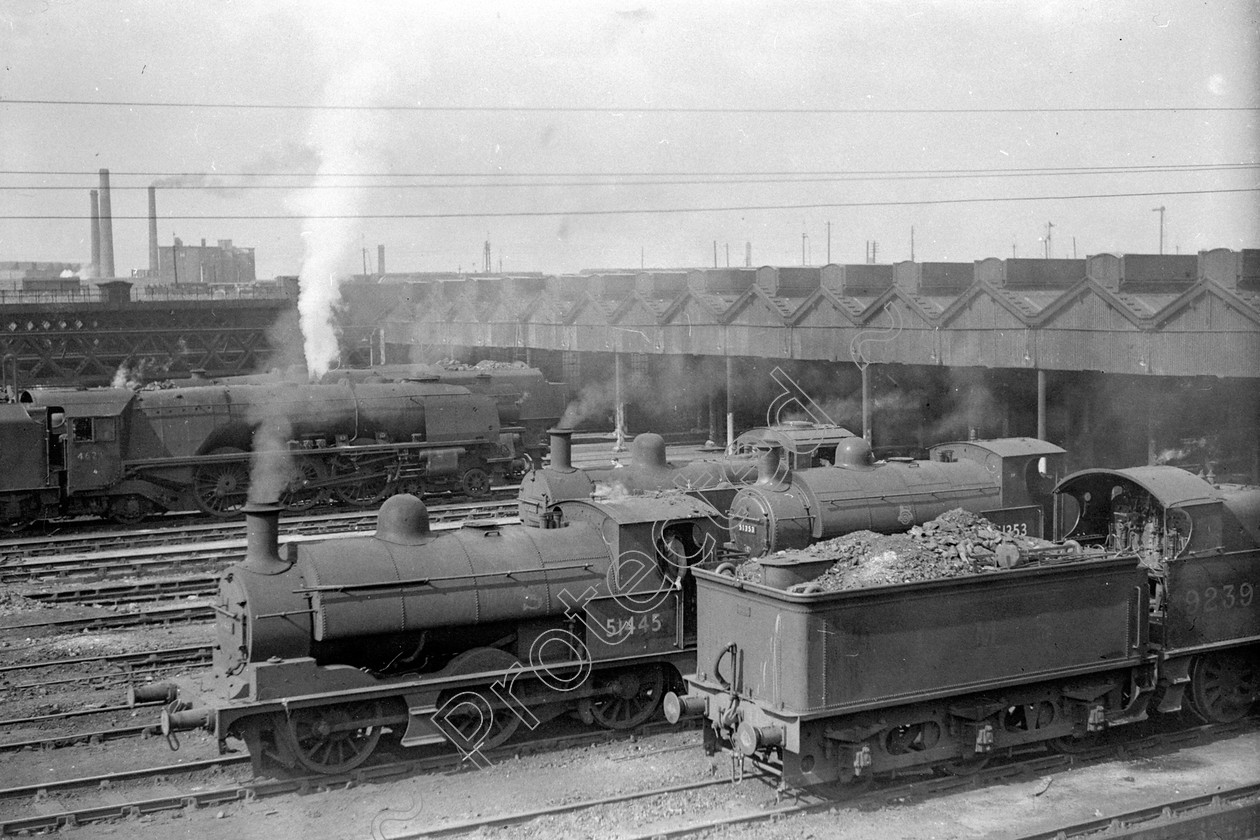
[730,436,1065,557]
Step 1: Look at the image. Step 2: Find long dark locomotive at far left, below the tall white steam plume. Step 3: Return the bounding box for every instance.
[0,372,562,530]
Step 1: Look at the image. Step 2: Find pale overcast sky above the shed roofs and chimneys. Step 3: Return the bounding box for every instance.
[0,0,1260,277]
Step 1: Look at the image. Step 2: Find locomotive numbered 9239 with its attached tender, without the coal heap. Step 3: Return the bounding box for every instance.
[665,467,1260,787]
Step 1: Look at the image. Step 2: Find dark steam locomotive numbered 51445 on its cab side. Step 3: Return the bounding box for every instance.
[164,494,722,773]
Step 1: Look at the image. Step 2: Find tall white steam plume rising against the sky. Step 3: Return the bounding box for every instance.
[292,60,389,382]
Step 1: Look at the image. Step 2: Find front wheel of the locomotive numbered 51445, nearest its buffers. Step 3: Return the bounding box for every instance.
[280,701,381,775]
